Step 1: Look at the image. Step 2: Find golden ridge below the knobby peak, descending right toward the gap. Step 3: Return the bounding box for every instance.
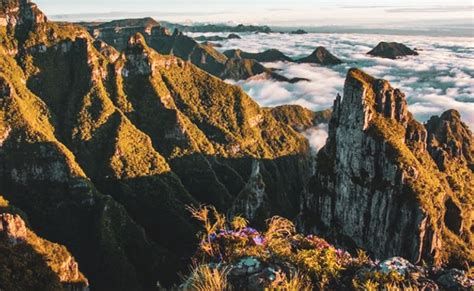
[114,35,307,219]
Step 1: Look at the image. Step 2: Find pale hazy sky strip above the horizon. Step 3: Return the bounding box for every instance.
[35,0,474,26]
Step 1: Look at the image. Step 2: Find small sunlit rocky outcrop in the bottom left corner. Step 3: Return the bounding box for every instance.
[0,196,89,290]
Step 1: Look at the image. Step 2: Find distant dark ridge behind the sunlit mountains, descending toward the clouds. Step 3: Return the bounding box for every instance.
[81,18,301,82]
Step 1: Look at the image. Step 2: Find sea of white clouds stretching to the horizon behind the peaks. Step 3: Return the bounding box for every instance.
[192,33,474,148]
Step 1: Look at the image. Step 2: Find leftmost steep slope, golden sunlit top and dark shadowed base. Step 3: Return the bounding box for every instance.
[0,43,183,288]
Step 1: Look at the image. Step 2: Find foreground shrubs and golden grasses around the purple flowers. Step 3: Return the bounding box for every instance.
[183,206,426,290]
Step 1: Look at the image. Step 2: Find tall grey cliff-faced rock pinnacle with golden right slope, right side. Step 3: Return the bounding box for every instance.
[304,69,474,265]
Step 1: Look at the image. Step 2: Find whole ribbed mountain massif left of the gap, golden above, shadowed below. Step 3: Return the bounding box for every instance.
[0,4,309,290]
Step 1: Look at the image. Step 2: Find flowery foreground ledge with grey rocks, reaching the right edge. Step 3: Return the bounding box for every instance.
[181,208,474,291]
